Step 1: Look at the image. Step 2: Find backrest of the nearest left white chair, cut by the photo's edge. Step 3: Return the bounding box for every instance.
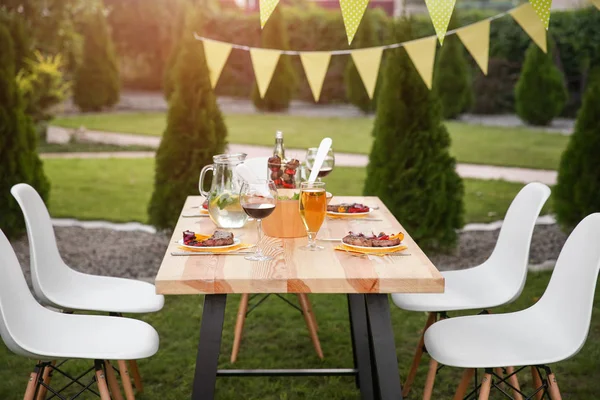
[0,230,42,357]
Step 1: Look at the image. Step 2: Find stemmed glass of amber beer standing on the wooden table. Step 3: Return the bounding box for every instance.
[299,182,327,251]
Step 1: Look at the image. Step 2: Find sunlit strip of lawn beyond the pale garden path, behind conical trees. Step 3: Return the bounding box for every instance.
[52,113,568,169]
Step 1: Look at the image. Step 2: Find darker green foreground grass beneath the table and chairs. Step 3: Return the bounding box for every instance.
[0,273,600,400]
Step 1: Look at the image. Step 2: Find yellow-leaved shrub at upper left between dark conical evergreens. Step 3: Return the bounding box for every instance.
[17,52,71,122]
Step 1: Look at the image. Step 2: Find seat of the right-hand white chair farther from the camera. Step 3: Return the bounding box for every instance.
[392,263,511,312]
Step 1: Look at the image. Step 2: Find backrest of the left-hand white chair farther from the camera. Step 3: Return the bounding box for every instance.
[10,183,71,304]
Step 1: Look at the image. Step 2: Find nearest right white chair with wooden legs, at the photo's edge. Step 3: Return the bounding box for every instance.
[425,213,600,400]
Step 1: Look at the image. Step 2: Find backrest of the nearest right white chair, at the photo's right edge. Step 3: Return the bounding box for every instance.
[532,213,600,355]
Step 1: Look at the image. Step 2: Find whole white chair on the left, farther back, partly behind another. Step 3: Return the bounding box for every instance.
[11,183,164,392]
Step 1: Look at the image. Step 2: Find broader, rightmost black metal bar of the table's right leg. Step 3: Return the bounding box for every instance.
[365,294,402,400]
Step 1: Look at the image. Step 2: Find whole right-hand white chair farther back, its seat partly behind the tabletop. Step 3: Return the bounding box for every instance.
[392,183,550,400]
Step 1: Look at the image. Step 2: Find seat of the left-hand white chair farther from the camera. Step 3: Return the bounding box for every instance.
[44,270,165,313]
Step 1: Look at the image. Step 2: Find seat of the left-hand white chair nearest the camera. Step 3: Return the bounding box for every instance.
[19,307,159,360]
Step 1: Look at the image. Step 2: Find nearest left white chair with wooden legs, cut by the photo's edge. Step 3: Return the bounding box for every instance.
[0,231,159,400]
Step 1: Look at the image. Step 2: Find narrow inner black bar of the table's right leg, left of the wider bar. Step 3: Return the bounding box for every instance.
[348,294,375,400]
